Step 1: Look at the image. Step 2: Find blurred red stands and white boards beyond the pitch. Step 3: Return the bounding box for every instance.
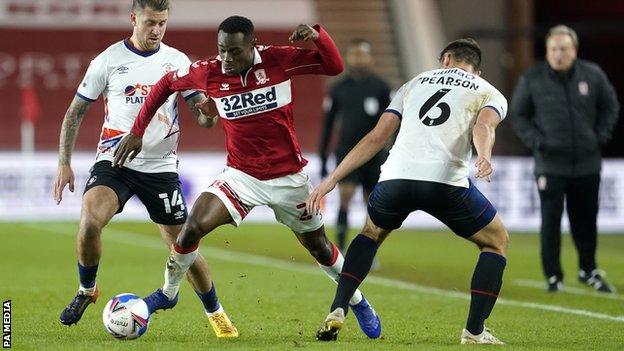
[0,0,624,232]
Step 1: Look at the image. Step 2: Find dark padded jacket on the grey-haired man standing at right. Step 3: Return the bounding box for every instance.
[510,59,619,177]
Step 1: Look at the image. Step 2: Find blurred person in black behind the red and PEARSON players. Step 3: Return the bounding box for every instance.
[319,39,390,251]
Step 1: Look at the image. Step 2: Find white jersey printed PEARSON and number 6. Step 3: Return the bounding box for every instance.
[379,68,507,187]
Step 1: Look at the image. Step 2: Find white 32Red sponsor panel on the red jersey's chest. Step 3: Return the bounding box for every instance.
[215,80,292,119]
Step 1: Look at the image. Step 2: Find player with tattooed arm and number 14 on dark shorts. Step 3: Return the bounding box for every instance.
[54,0,238,336]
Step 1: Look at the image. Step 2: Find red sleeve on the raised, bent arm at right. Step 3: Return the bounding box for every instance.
[274,24,344,76]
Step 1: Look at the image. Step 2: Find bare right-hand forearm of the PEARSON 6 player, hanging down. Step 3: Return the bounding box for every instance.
[472,107,501,182]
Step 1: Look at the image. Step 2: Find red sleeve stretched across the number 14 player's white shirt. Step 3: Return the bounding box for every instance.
[130,61,208,137]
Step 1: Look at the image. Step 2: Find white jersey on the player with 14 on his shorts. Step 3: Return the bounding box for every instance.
[76,39,197,173]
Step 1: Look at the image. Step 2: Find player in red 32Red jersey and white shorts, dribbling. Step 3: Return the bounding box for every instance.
[114,16,381,338]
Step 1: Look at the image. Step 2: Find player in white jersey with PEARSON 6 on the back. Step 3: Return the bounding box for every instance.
[306,39,509,344]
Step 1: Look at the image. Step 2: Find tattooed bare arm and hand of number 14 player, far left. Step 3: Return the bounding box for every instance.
[54,96,91,205]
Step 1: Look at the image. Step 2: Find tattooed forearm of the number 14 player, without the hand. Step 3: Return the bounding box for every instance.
[59,96,91,166]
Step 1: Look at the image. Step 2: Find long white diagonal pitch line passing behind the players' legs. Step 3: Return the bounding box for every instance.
[31,224,624,323]
